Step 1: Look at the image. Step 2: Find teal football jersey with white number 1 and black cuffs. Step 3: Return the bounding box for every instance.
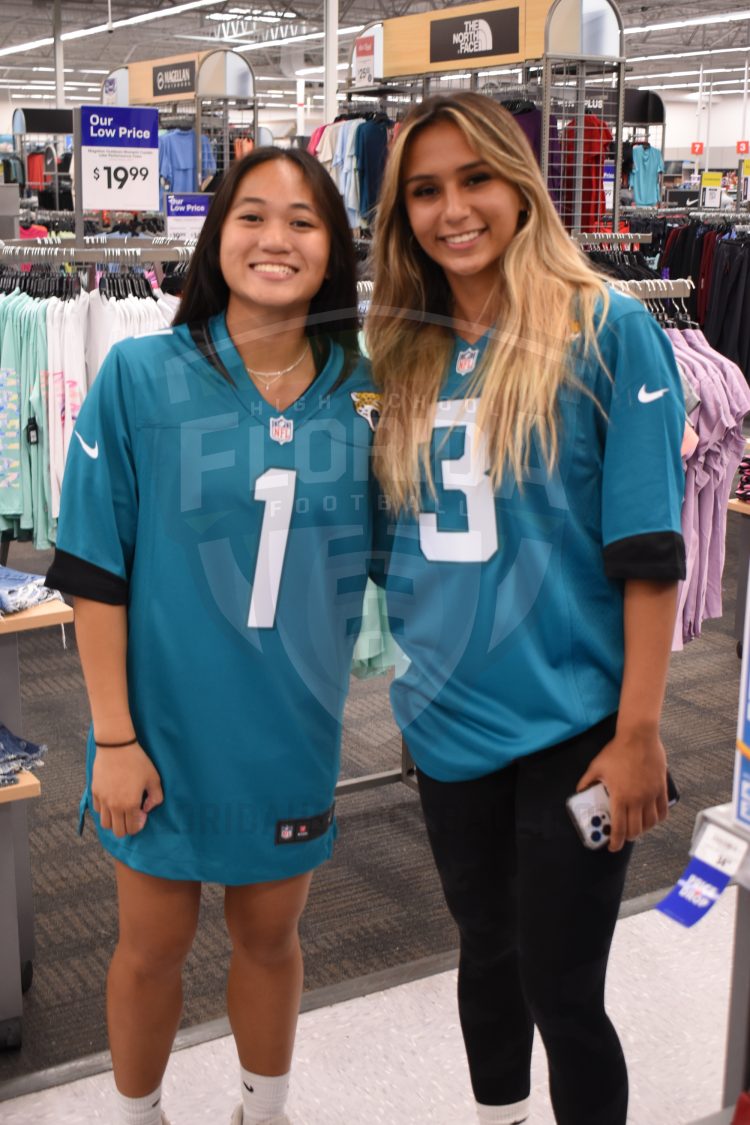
[47,315,378,884]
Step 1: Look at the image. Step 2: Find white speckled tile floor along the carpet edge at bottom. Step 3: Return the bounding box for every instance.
[0,890,735,1125]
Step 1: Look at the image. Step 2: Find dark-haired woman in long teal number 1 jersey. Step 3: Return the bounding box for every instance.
[48,149,377,1125]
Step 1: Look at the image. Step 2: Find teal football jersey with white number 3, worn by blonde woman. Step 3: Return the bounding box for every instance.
[378,291,685,781]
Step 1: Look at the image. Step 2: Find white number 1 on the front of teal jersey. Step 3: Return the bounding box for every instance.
[247,469,297,629]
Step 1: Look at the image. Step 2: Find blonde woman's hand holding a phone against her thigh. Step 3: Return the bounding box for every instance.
[576,731,668,852]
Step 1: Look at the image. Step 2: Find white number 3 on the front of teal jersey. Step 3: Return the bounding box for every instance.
[419,398,498,563]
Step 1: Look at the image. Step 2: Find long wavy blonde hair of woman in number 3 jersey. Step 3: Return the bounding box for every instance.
[367,92,608,511]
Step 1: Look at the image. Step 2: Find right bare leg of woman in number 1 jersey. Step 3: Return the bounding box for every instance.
[225,872,313,1078]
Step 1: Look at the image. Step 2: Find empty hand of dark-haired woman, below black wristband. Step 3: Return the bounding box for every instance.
[91,743,164,836]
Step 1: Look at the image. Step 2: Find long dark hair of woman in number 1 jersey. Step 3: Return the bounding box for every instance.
[173,145,358,362]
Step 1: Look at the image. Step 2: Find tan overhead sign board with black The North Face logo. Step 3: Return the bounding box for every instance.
[382,0,528,78]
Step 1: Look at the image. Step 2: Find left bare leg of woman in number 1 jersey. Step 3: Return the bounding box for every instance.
[107,861,200,1098]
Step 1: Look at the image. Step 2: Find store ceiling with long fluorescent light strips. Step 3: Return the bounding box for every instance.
[0,0,750,106]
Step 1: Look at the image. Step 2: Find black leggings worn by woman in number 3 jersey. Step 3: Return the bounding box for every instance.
[419,716,632,1125]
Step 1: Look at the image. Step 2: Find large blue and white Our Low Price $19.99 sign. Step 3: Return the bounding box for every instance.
[81,106,159,210]
